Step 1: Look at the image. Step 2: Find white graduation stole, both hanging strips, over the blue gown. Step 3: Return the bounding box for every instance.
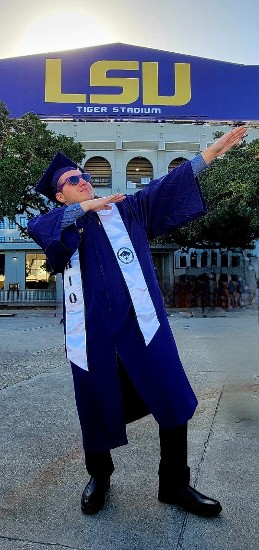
[64,205,160,370]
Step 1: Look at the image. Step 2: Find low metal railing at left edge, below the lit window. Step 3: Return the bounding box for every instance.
[0,289,56,304]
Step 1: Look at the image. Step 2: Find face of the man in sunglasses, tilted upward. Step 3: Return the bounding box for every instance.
[56,170,94,206]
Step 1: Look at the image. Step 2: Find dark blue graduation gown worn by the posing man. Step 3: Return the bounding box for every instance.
[28,162,207,452]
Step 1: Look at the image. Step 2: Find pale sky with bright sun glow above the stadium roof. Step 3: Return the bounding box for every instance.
[0,0,259,65]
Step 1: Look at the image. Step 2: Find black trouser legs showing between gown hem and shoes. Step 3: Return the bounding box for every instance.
[85,424,190,487]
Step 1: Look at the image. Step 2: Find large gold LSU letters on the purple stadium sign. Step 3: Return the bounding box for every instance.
[45,59,191,106]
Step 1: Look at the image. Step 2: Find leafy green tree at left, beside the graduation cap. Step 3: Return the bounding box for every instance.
[0,101,84,230]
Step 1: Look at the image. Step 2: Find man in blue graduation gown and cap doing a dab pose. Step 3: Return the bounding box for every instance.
[28,127,246,517]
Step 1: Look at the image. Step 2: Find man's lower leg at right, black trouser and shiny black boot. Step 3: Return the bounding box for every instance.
[158,424,222,517]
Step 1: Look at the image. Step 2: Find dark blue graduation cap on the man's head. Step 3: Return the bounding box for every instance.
[35,151,82,201]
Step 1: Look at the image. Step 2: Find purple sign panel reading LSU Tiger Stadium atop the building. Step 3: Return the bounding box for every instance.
[0,44,259,121]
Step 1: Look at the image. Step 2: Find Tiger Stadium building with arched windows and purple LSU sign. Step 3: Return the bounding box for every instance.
[0,44,259,307]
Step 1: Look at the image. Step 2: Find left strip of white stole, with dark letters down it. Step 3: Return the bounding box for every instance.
[64,250,88,370]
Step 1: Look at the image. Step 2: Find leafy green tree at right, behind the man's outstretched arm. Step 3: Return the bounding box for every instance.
[156,132,259,249]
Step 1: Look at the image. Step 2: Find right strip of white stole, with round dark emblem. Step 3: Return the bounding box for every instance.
[98,204,160,345]
